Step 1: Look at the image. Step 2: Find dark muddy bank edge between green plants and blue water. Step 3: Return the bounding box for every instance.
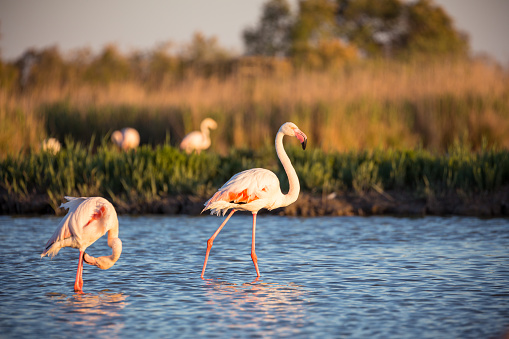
[0,186,509,218]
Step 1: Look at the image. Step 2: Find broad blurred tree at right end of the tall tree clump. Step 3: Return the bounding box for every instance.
[336,0,469,57]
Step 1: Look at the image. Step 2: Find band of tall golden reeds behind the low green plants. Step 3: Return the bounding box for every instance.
[0,60,509,157]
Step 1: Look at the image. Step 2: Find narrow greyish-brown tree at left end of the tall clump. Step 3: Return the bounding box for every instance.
[243,0,293,57]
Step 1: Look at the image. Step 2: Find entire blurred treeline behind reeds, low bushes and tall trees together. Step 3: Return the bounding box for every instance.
[0,0,469,91]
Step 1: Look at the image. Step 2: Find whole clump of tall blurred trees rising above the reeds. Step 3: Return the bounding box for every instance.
[244,0,469,61]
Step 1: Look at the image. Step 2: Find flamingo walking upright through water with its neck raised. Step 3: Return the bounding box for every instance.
[201,122,307,279]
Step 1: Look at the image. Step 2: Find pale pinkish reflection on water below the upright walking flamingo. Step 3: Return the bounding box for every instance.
[206,279,308,336]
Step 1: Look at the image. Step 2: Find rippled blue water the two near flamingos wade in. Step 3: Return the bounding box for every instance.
[0,213,509,338]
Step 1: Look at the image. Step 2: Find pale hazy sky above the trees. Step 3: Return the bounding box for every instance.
[0,0,509,67]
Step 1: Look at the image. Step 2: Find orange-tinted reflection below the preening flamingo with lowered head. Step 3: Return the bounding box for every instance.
[46,290,128,336]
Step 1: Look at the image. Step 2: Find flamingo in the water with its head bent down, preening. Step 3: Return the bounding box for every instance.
[41,197,122,292]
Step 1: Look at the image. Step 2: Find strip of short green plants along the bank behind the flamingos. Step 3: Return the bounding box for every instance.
[0,140,509,210]
